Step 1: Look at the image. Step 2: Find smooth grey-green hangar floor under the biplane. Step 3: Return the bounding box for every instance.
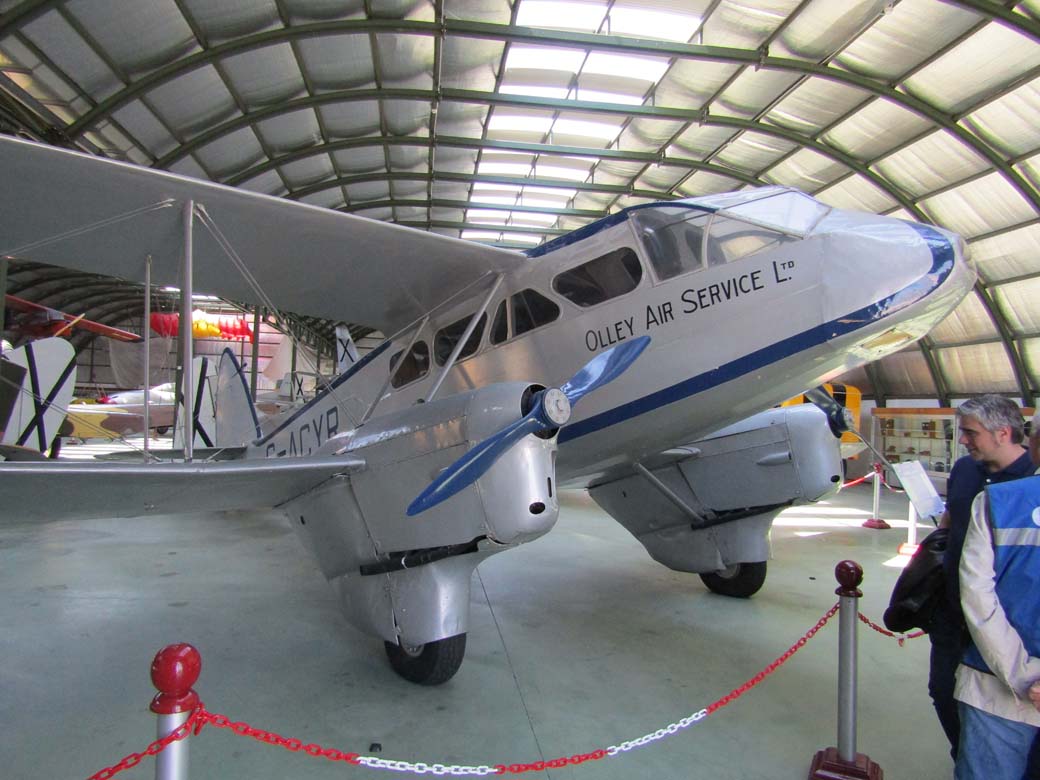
[0,470,952,780]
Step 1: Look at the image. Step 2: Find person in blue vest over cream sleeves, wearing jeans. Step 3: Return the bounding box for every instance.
[955,409,1040,780]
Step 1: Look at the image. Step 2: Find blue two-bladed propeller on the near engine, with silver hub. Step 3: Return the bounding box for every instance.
[408,336,650,517]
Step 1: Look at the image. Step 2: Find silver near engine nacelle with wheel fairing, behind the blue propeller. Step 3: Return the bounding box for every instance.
[283,383,560,645]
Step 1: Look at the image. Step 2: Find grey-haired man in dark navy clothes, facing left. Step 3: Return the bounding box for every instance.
[928,394,1035,759]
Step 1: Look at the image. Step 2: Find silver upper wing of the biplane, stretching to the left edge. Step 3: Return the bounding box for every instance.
[0,138,525,336]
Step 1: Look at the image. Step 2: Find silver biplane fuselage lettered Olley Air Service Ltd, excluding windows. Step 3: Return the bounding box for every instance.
[253,195,976,485]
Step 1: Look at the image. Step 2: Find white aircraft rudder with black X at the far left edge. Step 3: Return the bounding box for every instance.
[0,338,76,452]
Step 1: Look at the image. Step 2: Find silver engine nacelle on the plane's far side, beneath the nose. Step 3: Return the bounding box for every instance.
[589,405,841,573]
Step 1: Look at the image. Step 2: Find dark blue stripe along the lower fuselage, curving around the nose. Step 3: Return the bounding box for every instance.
[560,223,954,443]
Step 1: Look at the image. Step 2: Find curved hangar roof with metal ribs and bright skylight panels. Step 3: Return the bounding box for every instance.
[0,0,1040,404]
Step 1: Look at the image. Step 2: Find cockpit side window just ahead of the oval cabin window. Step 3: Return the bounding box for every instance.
[632,207,710,279]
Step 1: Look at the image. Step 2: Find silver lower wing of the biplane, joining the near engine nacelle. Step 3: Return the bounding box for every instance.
[0,458,364,521]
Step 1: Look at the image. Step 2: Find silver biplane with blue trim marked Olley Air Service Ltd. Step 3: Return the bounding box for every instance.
[0,140,974,684]
